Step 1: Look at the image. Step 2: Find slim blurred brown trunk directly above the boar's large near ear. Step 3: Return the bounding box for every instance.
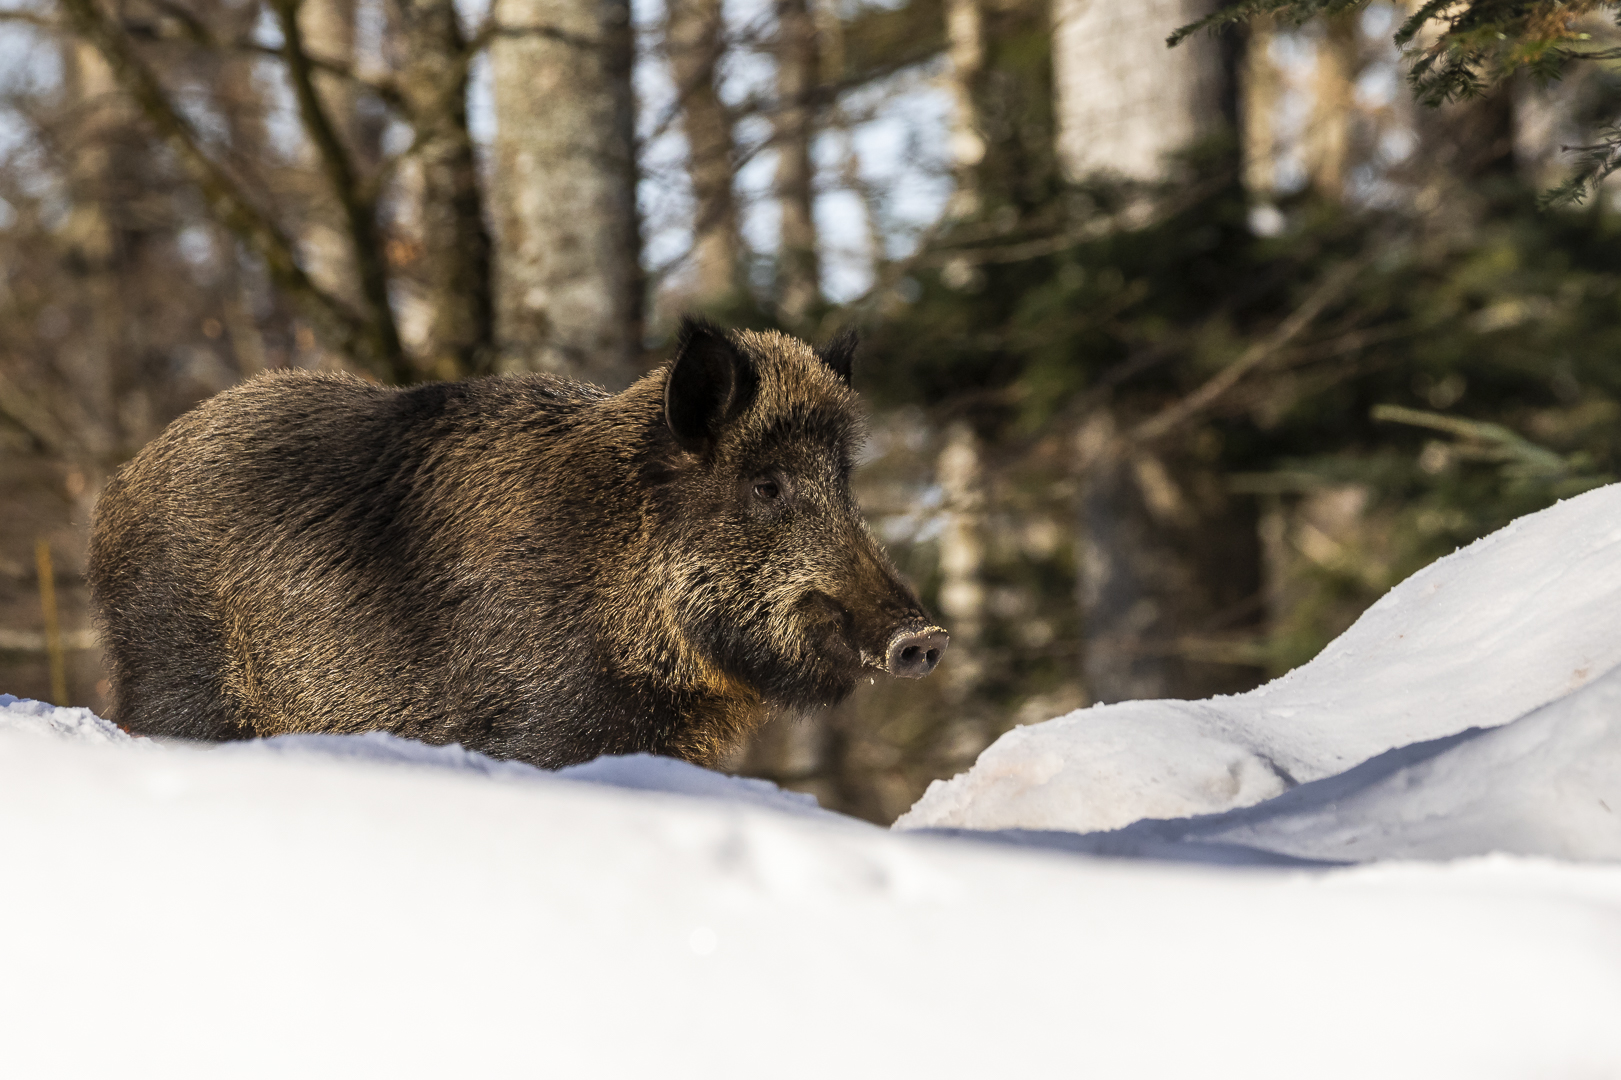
[665,0,741,302]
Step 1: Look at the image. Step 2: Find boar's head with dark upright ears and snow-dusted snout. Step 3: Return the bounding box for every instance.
[658,321,948,707]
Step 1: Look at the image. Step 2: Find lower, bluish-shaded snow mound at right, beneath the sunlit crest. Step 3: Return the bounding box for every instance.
[1076,670,1621,861]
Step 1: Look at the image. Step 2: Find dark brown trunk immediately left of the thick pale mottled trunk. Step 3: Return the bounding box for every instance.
[399,0,494,378]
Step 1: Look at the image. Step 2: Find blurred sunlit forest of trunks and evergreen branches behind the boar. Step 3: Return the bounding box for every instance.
[0,0,1621,822]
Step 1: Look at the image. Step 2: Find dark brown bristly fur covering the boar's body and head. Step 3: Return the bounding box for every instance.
[89,323,943,767]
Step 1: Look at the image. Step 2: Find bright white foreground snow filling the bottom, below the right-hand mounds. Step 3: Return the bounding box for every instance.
[0,702,1621,1080]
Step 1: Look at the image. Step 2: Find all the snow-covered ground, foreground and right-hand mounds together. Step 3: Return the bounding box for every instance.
[0,490,1621,1080]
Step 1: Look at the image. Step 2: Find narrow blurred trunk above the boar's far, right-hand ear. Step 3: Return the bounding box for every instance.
[775,0,822,324]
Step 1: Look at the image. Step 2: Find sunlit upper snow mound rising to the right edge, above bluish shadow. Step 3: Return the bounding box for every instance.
[895,485,1621,832]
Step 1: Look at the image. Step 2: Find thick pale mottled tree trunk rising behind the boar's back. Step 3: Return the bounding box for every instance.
[490,0,642,388]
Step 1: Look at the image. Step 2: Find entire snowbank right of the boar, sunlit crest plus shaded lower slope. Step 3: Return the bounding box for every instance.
[896,485,1621,858]
